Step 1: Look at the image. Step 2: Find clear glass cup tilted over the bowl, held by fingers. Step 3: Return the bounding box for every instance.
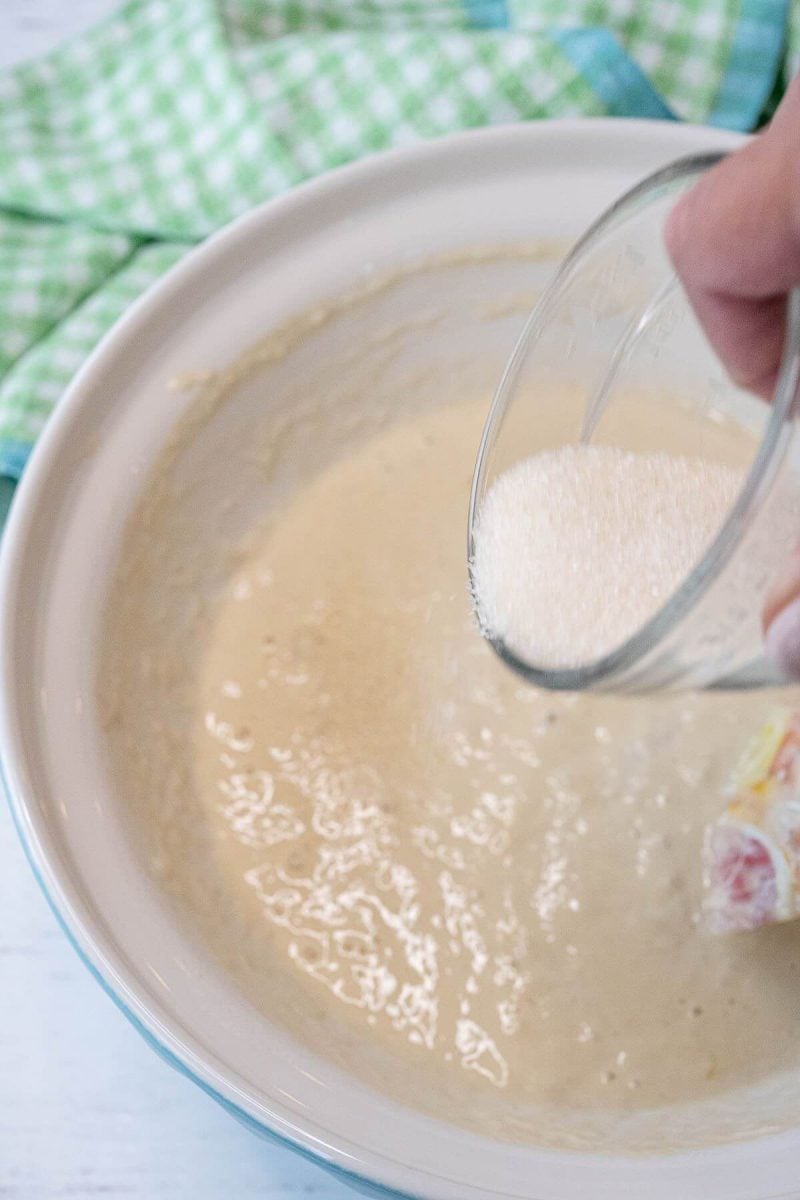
[468,155,800,692]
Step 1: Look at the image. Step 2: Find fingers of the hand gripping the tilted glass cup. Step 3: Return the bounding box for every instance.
[666,76,800,679]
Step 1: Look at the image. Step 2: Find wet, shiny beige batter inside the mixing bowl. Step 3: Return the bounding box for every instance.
[101,367,800,1145]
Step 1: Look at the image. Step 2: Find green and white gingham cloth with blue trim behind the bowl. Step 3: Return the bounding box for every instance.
[0,0,800,479]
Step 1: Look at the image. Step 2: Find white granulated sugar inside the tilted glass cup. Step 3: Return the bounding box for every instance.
[473,445,741,667]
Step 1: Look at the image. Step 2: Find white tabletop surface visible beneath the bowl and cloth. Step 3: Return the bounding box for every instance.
[0,0,354,1200]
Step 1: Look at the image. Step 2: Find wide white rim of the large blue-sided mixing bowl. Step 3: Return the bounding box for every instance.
[0,121,800,1200]
